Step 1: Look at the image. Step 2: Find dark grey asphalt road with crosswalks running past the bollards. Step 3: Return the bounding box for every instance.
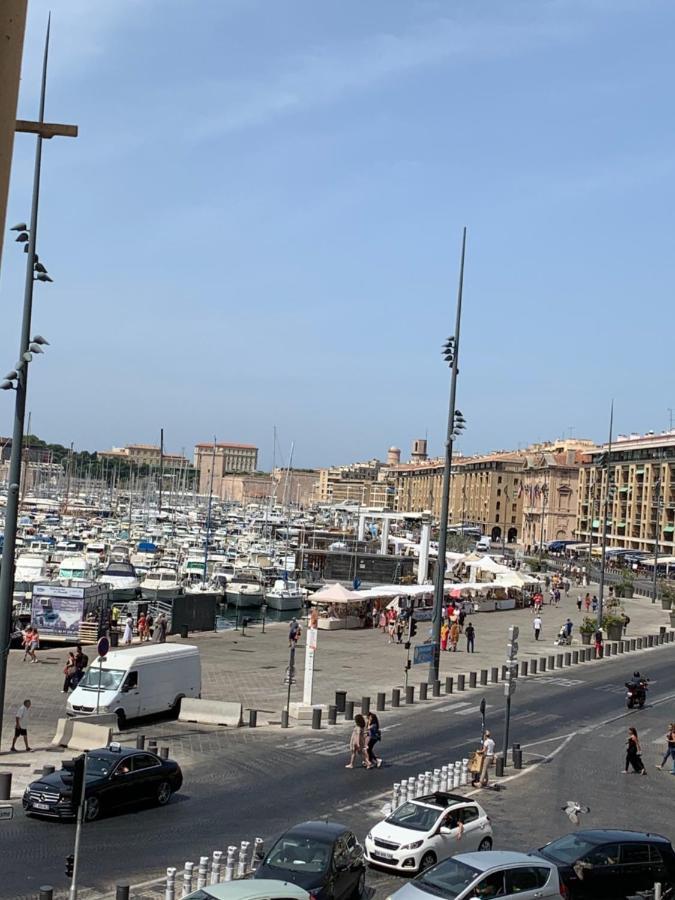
[5,645,675,898]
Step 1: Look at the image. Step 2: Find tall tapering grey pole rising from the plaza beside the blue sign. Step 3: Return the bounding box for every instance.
[428,226,466,684]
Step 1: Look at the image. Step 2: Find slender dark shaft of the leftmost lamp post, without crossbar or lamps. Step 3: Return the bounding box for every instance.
[0,24,49,741]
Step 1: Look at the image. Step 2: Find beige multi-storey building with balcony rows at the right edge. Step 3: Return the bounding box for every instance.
[576,431,675,555]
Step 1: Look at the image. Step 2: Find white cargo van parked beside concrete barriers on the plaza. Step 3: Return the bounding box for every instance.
[66,644,202,725]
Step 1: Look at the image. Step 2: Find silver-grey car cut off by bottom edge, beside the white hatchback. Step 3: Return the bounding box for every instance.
[391,850,565,900]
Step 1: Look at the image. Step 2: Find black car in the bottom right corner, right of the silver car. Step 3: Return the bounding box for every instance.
[536,828,675,900]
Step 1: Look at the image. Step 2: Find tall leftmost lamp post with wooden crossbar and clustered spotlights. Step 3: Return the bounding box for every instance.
[0,23,77,740]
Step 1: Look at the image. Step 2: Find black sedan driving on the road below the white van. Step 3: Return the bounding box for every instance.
[23,744,183,822]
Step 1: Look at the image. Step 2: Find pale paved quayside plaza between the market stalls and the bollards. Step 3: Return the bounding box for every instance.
[0,586,670,797]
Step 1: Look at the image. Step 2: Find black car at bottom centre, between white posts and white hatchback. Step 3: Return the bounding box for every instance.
[253,822,366,900]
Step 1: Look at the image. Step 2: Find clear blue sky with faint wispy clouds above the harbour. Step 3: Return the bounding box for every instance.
[0,0,675,468]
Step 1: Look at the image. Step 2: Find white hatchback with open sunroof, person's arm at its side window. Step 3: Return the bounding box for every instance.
[365,791,492,872]
